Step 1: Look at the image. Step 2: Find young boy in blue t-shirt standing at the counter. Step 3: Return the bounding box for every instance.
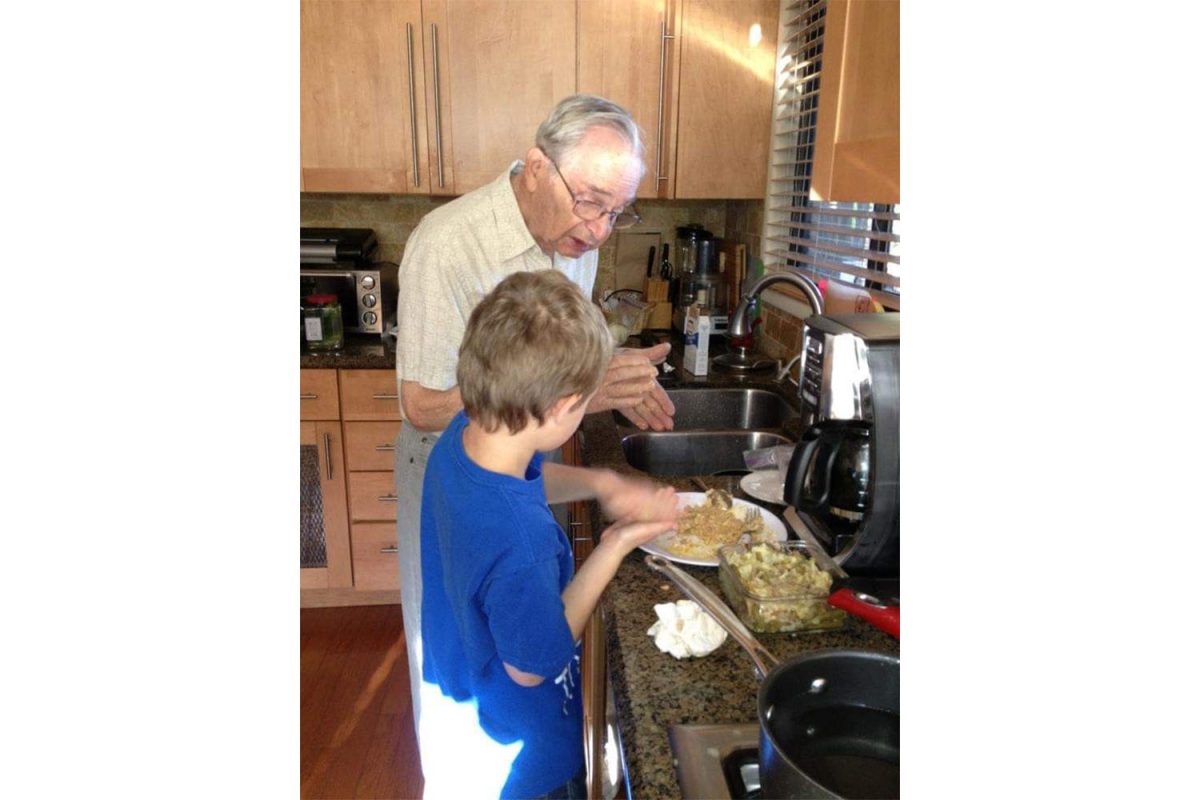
[420,270,677,799]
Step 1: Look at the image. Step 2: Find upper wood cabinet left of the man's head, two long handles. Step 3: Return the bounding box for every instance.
[300,0,575,194]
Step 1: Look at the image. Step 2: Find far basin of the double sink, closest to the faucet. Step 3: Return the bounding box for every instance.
[613,389,799,431]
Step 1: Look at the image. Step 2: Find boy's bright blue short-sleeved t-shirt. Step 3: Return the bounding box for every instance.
[421,411,583,798]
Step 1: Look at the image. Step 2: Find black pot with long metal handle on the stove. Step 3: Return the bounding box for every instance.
[646,555,900,800]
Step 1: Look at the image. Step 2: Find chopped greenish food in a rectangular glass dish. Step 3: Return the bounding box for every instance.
[718,542,846,633]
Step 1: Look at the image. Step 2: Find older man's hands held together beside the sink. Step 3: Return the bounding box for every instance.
[588,342,674,431]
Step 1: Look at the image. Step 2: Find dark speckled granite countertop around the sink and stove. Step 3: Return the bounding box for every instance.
[580,336,900,800]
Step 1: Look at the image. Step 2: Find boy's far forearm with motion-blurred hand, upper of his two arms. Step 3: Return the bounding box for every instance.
[542,463,678,530]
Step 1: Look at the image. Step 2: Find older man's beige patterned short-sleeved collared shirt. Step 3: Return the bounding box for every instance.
[396,161,598,422]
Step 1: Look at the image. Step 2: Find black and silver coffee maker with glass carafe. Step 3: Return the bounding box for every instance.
[784,313,900,577]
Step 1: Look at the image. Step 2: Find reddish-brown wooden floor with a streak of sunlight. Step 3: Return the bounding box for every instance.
[300,606,424,800]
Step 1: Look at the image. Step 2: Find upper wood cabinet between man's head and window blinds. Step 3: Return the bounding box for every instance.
[578,0,779,199]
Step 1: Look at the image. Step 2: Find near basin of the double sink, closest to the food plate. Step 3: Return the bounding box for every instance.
[620,431,792,477]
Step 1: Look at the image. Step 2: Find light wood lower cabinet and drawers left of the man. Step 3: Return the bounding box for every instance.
[300,369,401,607]
